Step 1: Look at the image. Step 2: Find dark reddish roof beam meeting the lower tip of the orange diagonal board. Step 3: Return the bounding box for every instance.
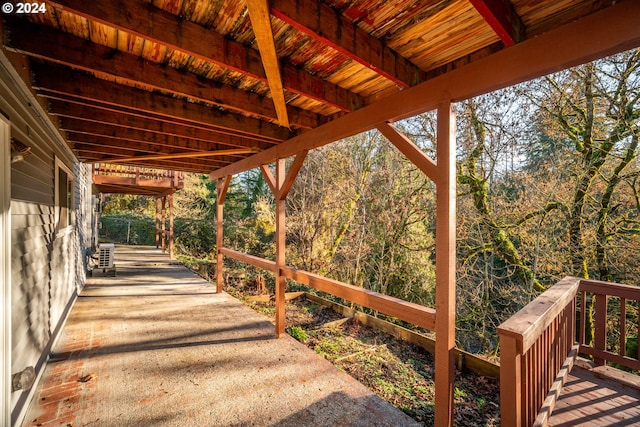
[31,62,291,140]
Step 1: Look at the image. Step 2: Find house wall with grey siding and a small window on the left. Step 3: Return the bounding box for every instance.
[0,53,92,424]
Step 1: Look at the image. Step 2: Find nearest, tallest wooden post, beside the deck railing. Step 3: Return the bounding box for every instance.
[435,102,456,426]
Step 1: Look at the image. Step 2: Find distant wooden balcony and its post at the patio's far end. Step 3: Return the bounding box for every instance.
[91,163,184,258]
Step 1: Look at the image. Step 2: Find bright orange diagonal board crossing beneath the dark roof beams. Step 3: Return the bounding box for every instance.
[247,0,289,128]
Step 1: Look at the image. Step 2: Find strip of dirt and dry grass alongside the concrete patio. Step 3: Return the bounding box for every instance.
[220,268,500,427]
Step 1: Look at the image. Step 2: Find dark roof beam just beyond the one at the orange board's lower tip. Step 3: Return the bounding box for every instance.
[44,99,275,148]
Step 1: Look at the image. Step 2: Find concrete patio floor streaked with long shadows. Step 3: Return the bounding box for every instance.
[23,246,417,427]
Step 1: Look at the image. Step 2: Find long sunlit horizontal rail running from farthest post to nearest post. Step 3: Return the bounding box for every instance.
[219,248,436,330]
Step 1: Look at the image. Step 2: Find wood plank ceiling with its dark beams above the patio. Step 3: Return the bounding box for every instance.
[2,0,635,173]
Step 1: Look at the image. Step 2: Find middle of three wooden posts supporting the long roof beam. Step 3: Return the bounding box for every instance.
[276,159,286,337]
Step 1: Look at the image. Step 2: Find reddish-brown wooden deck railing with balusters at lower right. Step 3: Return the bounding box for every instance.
[498,277,640,427]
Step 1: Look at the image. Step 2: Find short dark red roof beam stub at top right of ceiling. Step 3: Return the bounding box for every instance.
[469,0,525,47]
